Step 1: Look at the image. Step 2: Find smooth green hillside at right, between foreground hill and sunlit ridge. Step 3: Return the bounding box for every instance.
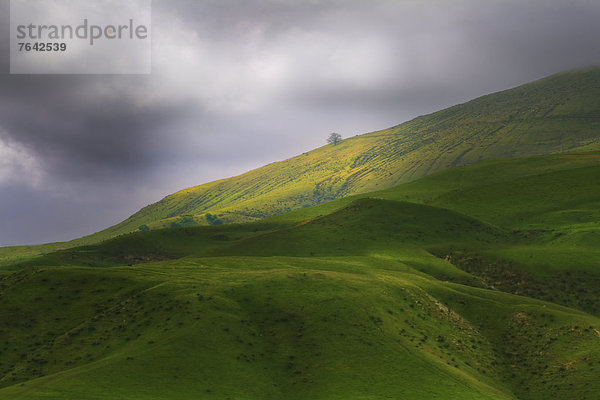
[271,153,600,315]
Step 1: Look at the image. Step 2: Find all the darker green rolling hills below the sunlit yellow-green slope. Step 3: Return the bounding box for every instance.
[0,153,600,399]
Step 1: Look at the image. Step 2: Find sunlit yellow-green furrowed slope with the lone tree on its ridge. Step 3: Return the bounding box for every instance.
[99,68,600,237]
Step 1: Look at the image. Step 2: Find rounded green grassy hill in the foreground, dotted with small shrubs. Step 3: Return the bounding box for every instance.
[0,254,600,399]
